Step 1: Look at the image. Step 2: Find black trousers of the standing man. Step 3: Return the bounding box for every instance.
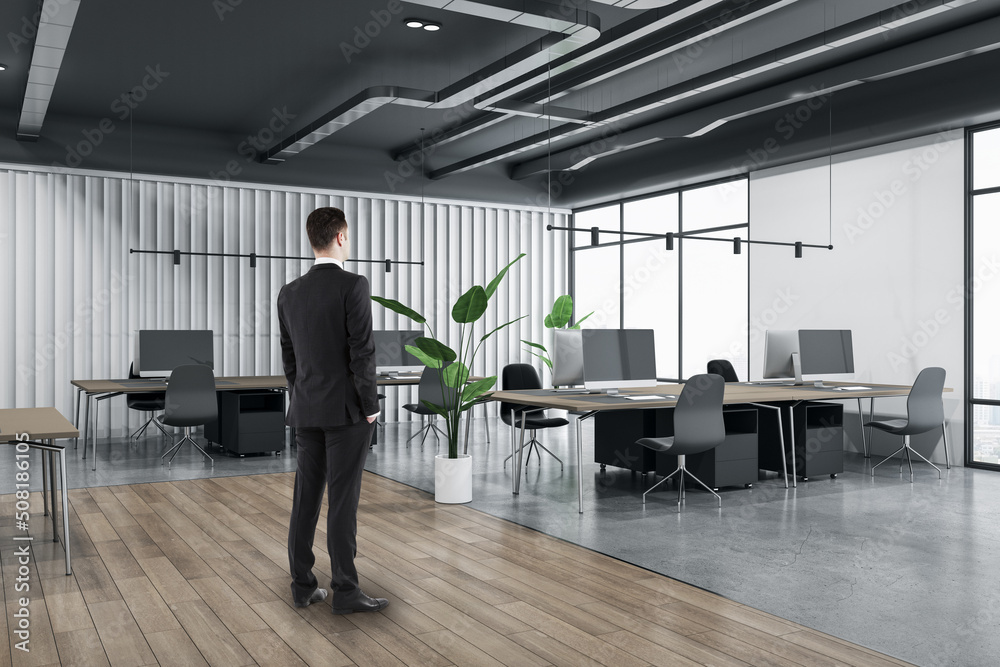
[288,419,375,602]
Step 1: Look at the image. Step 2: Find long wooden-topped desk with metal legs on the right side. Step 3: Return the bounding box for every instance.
[490,382,924,514]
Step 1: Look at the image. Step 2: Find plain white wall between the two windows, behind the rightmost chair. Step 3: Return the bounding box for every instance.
[750,131,965,463]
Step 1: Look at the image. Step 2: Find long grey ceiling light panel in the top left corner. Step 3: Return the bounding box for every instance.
[17,0,80,141]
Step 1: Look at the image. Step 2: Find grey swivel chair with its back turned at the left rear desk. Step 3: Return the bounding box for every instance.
[160,364,219,467]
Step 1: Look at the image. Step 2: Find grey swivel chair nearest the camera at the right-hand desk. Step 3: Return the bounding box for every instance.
[636,374,726,512]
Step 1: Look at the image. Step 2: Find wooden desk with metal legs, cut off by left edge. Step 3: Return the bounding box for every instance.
[0,408,80,575]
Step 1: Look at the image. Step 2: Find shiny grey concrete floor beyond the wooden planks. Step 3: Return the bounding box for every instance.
[0,418,1000,666]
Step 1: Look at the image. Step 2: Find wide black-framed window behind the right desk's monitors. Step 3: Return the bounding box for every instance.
[570,178,749,379]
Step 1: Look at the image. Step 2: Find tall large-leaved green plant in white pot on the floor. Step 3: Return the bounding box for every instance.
[372,253,527,503]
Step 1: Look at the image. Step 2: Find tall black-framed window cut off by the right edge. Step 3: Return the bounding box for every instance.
[966,126,1000,468]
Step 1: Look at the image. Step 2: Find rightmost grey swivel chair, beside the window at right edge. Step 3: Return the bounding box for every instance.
[865,366,948,482]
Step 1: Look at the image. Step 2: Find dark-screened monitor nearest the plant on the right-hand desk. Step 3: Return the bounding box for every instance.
[582,329,656,393]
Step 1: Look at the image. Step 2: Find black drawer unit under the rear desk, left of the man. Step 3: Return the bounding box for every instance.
[205,389,285,456]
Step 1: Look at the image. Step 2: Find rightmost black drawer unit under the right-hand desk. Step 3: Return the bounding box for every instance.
[760,401,844,479]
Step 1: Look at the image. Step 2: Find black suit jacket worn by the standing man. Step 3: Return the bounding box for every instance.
[278,264,379,427]
